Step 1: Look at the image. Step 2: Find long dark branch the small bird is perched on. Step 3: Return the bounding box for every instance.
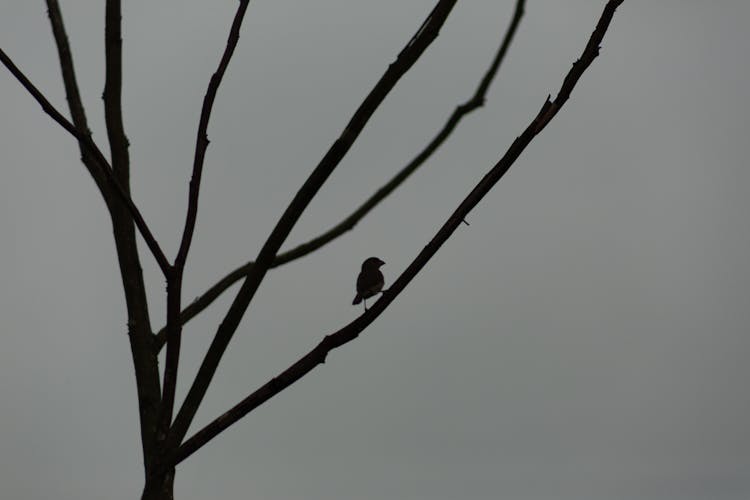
[170,0,623,466]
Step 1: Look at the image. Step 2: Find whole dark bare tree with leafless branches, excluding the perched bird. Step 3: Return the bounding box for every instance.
[0,0,623,499]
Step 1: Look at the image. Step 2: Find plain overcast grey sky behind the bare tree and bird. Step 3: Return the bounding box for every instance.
[0,0,750,500]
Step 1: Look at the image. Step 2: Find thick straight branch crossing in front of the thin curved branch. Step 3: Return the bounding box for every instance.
[167,0,456,449]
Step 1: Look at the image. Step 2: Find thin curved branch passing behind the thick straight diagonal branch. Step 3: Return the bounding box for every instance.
[154,0,526,350]
